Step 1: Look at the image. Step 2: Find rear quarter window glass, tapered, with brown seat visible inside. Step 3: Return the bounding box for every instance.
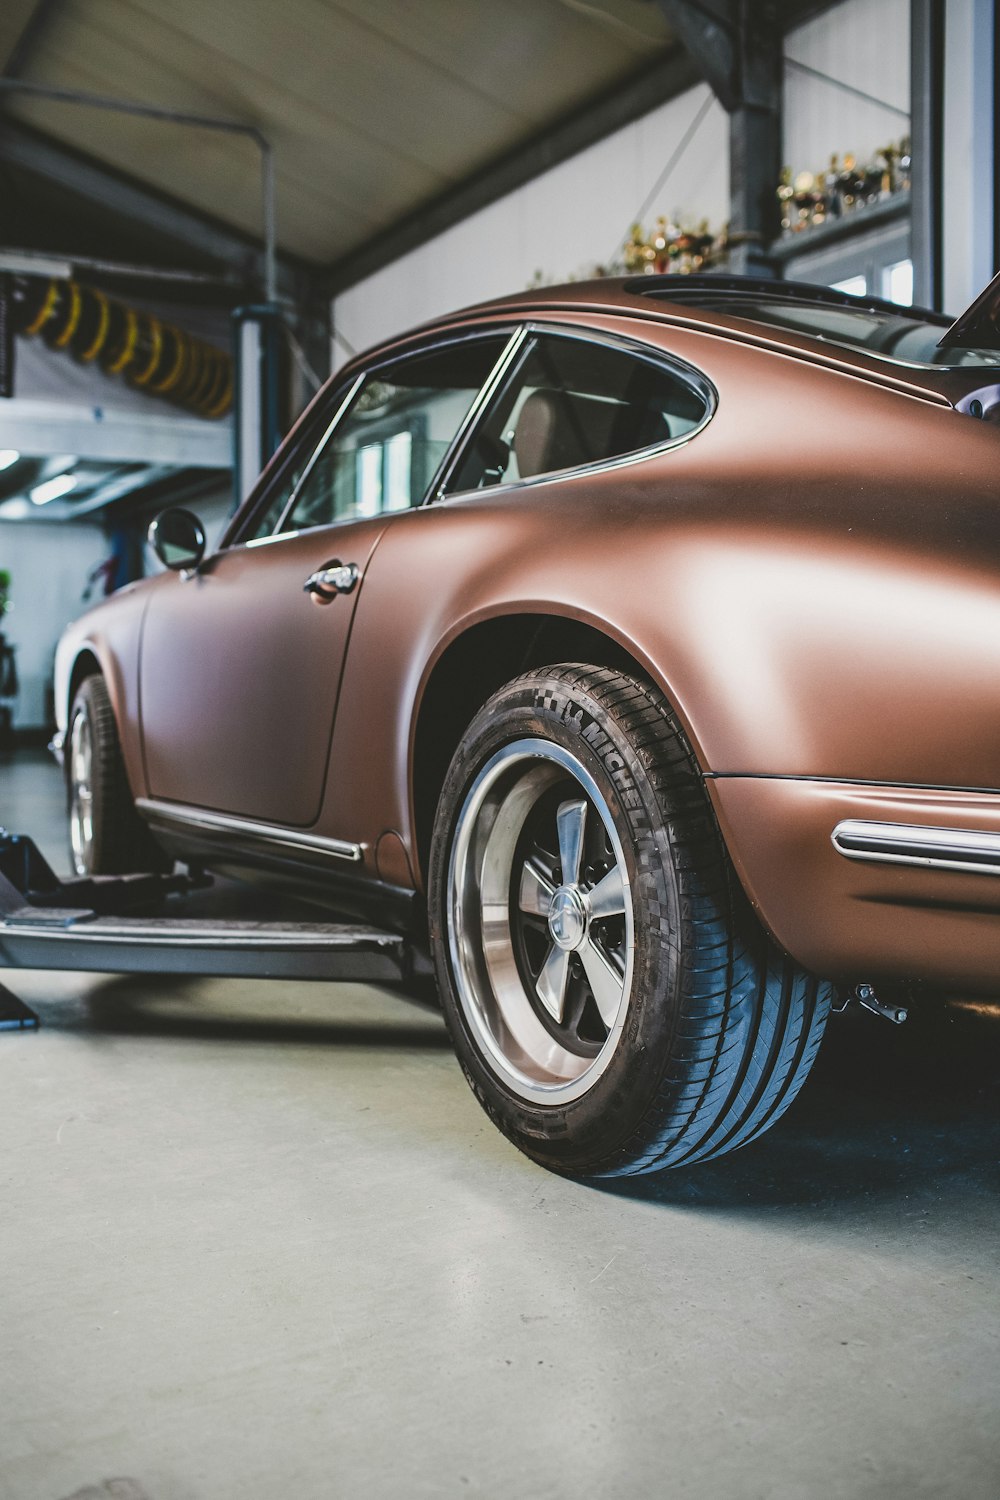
[447,333,708,494]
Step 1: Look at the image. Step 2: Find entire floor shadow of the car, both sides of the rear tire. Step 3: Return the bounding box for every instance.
[15,975,1000,1218]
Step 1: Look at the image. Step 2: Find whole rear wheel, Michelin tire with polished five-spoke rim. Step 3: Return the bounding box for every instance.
[429,665,834,1176]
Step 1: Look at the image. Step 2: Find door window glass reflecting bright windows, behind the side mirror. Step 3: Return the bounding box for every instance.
[262,333,508,537]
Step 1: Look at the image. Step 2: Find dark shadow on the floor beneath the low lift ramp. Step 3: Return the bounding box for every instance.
[36,975,450,1050]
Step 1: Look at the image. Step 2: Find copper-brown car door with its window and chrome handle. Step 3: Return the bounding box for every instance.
[139,332,510,828]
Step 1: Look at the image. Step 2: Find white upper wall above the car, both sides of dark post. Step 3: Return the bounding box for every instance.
[333,0,923,365]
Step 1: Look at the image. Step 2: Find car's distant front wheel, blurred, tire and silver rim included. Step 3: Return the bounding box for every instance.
[64,675,169,876]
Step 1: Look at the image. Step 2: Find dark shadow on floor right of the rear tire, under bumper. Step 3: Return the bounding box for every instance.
[595,1002,1000,1227]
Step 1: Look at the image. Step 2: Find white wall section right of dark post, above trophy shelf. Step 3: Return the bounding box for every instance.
[783,0,911,173]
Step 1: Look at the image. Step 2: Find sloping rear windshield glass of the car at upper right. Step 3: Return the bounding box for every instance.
[643,288,1000,369]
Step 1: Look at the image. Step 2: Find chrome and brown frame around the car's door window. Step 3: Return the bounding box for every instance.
[223,320,525,552]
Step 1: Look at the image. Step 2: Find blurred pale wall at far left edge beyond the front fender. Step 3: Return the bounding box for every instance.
[0,521,109,729]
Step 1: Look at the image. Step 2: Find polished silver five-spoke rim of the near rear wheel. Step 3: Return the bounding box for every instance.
[448,740,634,1104]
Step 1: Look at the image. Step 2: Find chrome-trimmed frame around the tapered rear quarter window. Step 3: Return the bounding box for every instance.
[434,321,718,504]
